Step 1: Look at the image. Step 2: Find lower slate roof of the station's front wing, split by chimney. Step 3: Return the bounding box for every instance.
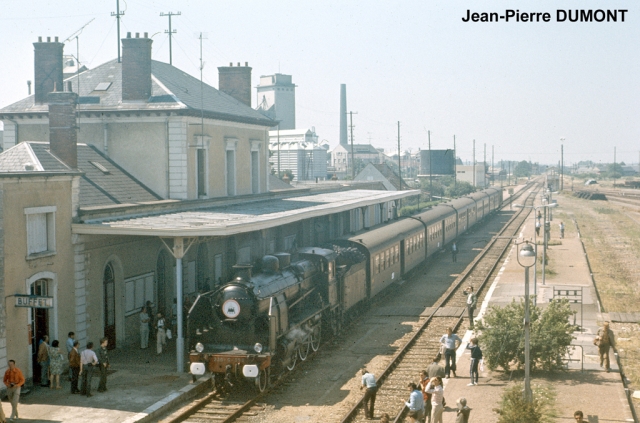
[0,141,162,207]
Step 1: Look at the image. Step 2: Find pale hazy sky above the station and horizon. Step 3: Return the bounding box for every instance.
[0,0,640,166]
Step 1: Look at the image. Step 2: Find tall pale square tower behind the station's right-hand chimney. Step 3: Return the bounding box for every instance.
[257,73,296,130]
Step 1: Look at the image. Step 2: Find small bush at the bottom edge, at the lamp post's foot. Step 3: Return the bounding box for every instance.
[493,383,555,423]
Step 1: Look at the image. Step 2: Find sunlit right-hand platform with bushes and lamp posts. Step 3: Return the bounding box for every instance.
[443,197,633,423]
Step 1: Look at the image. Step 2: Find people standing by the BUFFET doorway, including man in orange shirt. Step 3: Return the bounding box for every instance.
[0,332,110,423]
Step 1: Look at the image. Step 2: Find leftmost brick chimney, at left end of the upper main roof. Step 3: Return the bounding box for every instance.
[33,37,64,104]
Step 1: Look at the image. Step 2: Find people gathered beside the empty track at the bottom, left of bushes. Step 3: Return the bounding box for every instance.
[360,328,482,423]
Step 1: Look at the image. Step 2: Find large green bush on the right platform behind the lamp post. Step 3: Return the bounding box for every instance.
[478,300,574,371]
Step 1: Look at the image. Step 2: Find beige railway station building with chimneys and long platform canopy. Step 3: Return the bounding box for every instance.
[0,34,417,381]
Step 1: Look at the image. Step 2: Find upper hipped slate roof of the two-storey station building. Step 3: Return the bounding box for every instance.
[0,60,276,127]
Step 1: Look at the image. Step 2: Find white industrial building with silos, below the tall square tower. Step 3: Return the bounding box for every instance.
[269,128,329,181]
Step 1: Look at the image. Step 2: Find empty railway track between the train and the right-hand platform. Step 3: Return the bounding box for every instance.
[341,182,538,423]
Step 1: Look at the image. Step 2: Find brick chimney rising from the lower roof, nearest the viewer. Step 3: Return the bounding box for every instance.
[48,91,78,169]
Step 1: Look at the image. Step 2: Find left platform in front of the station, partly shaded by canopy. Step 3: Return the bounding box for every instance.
[2,340,210,423]
